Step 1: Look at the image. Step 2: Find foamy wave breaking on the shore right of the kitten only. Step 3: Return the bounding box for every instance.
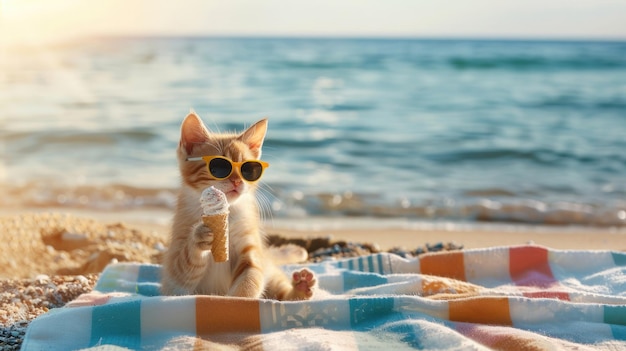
[276,192,626,227]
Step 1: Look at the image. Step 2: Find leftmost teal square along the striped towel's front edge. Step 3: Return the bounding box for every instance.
[90,300,141,350]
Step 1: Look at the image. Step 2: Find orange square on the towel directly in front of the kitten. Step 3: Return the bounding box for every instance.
[196,296,261,336]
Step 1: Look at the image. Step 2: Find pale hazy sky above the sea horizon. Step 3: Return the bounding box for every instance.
[0,0,626,43]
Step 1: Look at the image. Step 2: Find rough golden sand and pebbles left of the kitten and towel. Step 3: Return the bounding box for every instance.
[0,209,165,350]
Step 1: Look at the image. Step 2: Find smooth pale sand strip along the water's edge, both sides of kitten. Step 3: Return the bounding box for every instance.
[0,207,626,251]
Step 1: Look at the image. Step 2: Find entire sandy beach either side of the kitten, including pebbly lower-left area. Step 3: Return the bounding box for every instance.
[0,208,626,350]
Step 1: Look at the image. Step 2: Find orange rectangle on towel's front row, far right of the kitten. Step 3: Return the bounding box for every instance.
[448,297,513,325]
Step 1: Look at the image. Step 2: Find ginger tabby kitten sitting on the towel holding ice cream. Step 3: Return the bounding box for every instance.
[161,112,316,300]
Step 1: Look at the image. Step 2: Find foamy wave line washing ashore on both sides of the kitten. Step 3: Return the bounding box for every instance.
[6,182,626,227]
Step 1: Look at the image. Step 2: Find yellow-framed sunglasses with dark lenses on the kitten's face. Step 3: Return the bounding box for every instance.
[186,156,270,182]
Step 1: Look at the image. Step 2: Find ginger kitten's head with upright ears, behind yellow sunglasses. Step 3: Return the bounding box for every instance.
[177,112,267,204]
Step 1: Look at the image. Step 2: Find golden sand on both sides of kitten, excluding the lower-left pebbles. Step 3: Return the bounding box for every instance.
[0,208,626,279]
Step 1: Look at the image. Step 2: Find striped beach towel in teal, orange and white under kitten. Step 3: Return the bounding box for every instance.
[23,246,626,350]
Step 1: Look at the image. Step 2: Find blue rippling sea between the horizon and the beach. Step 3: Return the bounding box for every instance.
[0,37,626,228]
